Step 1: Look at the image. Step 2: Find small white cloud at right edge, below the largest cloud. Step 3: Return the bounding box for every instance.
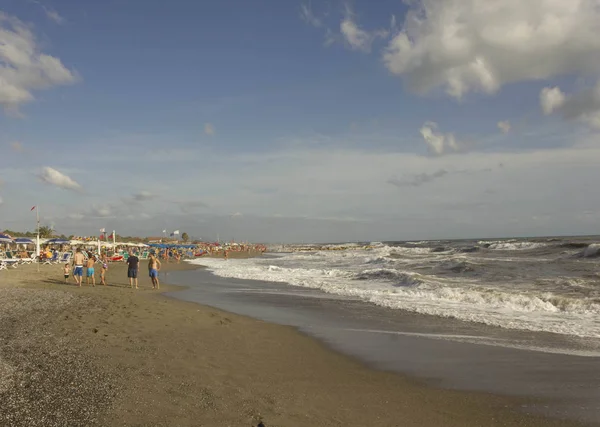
[540,80,600,129]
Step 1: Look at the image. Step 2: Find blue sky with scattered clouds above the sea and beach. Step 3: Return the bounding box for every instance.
[0,0,600,243]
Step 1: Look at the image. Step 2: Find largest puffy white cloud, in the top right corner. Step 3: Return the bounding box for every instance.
[383,0,600,98]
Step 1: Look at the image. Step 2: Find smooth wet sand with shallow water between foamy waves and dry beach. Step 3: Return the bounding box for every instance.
[168,270,600,424]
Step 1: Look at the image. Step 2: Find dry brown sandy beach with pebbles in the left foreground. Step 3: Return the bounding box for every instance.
[0,263,592,427]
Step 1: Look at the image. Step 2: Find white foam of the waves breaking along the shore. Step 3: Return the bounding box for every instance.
[192,246,600,338]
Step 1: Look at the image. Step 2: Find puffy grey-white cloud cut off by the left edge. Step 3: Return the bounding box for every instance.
[0,12,77,114]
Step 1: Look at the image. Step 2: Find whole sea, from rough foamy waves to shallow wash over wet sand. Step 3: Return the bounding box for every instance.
[177,236,600,426]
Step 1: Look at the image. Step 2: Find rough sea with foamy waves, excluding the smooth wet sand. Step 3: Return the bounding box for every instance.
[188,236,600,356]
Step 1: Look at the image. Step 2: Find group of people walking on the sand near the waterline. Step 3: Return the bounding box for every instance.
[63,248,161,289]
